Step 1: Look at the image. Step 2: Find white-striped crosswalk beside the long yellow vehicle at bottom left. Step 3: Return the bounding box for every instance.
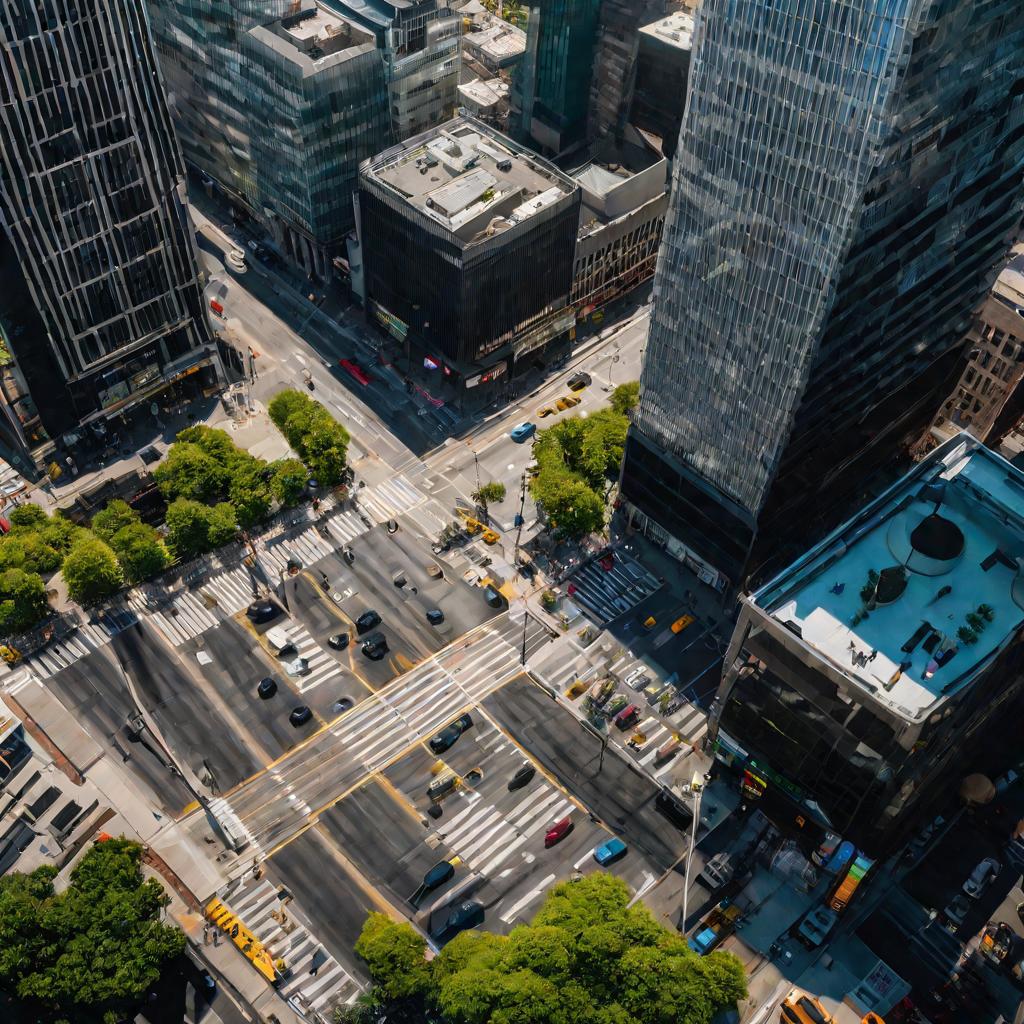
[217,876,362,1021]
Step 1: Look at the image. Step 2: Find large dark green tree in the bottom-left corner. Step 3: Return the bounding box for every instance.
[0,839,185,1021]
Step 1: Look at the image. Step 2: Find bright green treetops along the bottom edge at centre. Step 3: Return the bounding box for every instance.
[350,872,746,1024]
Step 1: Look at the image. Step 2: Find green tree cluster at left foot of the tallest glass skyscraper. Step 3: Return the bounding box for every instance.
[530,381,640,540]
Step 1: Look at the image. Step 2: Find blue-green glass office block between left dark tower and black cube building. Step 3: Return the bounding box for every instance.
[151,0,391,280]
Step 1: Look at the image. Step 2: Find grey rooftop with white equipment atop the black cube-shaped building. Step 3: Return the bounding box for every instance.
[360,116,578,246]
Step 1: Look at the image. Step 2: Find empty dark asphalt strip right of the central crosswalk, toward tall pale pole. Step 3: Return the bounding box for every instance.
[483,678,687,872]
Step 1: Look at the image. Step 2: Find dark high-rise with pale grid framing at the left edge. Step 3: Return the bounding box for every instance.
[0,0,219,469]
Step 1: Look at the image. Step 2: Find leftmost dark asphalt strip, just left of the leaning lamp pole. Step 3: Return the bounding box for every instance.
[39,648,193,815]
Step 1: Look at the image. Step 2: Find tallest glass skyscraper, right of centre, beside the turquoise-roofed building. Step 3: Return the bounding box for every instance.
[623,0,1024,585]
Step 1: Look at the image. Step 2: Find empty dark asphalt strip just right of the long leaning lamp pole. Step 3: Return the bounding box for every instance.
[111,623,265,790]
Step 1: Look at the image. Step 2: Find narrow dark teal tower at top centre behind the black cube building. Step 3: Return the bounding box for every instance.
[513,0,601,156]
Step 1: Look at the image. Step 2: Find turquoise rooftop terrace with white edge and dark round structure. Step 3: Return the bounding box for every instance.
[750,434,1024,721]
